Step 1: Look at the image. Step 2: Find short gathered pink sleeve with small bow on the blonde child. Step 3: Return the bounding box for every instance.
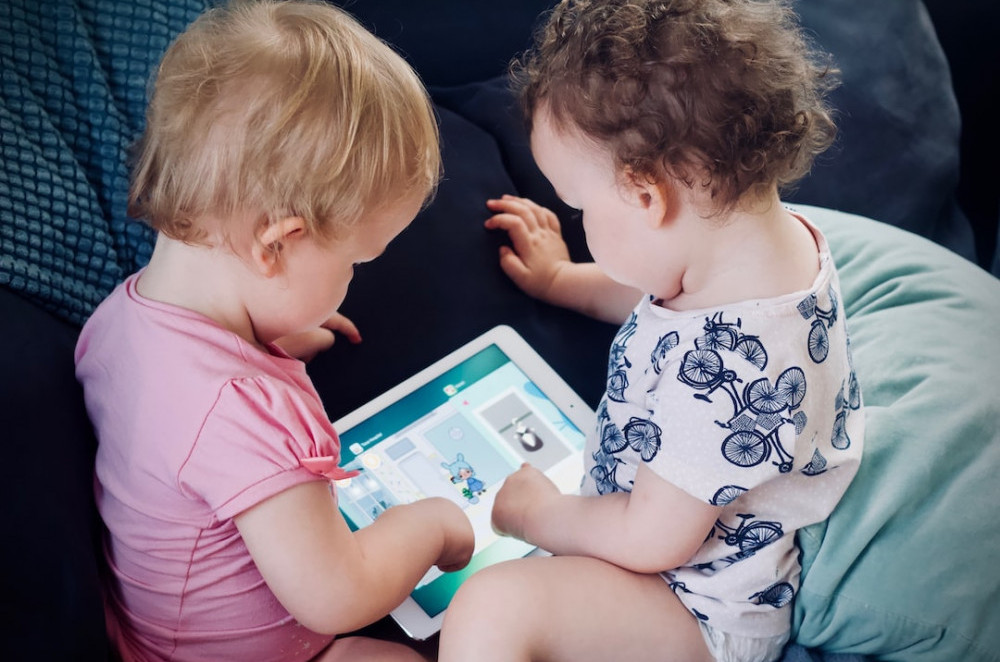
[178,377,340,520]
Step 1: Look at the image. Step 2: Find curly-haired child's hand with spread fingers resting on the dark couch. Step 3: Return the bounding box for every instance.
[485,195,572,303]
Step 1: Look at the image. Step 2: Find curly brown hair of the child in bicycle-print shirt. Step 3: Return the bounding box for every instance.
[511,0,838,211]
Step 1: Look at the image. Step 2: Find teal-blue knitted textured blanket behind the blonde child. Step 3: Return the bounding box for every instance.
[0,0,207,324]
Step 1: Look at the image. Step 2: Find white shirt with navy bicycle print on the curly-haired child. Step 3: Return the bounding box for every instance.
[582,219,864,637]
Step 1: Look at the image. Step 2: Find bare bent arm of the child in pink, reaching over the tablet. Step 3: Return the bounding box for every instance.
[235,481,474,634]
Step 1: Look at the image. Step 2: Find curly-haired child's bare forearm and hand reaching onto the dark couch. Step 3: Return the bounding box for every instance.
[486,195,641,324]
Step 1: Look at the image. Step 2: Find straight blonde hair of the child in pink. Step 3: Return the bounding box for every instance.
[128,0,441,243]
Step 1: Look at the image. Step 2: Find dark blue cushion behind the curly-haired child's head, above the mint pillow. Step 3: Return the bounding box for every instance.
[786,0,976,261]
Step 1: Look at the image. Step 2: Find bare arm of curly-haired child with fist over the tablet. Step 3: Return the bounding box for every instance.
[493,465,720,573]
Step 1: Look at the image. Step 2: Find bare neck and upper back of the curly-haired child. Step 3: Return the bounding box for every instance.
[662,194,819,310]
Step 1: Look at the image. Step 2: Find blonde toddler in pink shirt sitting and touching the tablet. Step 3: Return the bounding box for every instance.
[75,1,473,661]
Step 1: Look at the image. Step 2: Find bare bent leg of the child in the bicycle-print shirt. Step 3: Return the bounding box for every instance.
[438,556,711,662]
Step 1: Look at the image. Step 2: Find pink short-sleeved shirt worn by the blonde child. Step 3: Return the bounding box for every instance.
[76,275,354,660]
